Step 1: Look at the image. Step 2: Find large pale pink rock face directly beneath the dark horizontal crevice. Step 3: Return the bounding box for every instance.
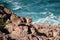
[10,26,28,38]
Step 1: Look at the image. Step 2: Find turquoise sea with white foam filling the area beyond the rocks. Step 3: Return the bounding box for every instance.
[0,0,60,25]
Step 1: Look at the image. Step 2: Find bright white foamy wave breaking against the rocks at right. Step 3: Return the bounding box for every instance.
[33,12,60,25]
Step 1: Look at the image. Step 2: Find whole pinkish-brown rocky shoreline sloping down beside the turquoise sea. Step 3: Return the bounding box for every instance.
[0,5,60,40]
